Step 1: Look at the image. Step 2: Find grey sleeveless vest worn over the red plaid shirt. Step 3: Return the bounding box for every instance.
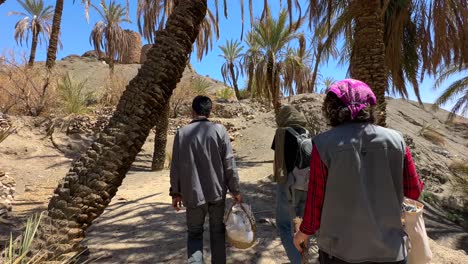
[313,123,406,263]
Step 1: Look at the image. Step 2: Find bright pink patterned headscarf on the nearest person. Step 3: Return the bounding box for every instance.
[327,79,377,119]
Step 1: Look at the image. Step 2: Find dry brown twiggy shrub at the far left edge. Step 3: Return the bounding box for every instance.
[0,53,57,116]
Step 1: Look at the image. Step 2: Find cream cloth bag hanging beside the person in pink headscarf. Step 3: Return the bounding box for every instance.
[403,198,432,264]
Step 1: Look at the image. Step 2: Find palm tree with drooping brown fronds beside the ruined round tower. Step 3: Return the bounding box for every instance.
[89,0,131,72]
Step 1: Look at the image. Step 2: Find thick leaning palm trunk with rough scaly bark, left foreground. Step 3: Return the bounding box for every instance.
[33,0,207,256]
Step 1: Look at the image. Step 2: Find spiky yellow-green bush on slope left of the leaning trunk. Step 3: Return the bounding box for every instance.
[57,74,94,114]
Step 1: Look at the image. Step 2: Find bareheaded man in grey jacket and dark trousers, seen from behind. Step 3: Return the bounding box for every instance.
[170,96,241,264]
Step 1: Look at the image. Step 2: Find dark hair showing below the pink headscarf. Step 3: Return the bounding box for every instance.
[322,92,375,127]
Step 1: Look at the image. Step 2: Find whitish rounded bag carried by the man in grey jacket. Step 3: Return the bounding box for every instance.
[224,204,256,249]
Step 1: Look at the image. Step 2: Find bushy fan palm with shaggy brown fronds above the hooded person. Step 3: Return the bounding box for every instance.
[244,8,310,98]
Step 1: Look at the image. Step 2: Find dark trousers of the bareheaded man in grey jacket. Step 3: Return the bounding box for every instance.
[187,200,226,264]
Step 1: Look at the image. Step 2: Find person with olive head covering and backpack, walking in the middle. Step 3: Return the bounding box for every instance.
[271,105,312,264]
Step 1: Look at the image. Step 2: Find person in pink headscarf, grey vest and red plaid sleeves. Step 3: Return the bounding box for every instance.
[294,79,424,264]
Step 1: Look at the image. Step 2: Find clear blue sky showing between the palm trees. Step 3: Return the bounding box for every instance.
[0,0,460,111]
